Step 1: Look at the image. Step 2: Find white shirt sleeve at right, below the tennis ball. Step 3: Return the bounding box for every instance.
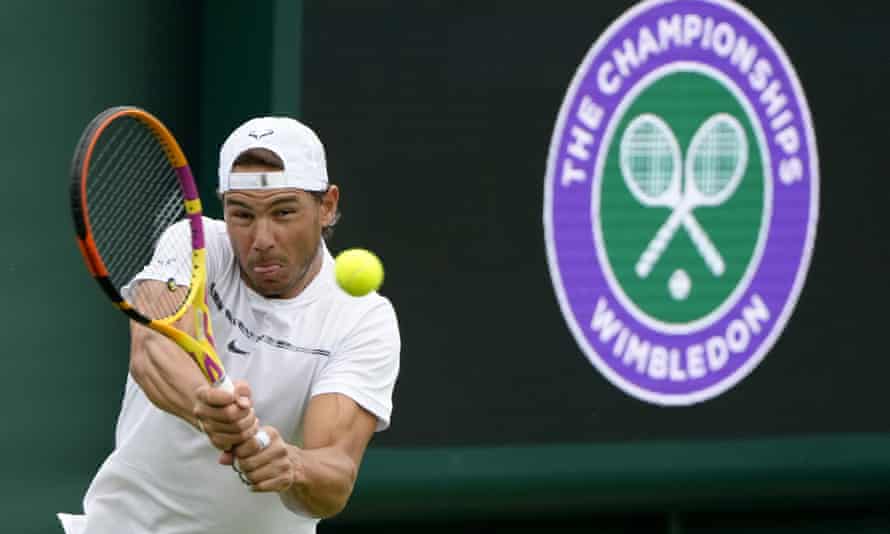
[311,297,401,432]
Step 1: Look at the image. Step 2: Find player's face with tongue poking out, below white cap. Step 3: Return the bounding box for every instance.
[223,166,338,298]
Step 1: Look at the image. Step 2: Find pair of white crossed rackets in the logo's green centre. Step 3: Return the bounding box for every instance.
[619,113,748,278]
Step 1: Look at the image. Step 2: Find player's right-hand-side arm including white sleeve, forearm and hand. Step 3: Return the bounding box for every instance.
[234,300,401,517]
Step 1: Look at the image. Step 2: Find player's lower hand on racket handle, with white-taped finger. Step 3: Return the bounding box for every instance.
[232,426,299,492]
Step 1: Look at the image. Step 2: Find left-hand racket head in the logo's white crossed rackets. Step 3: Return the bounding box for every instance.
[619,113,682,207]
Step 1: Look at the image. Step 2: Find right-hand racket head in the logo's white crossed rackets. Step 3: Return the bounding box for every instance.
[686,113,748,206]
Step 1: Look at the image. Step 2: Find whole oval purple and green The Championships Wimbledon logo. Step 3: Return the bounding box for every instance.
[544,0,819,405]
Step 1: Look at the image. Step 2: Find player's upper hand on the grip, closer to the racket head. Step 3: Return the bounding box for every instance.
[193,380,253,451]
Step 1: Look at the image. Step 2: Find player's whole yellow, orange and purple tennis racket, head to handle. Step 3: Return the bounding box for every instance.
[71,107,234,392]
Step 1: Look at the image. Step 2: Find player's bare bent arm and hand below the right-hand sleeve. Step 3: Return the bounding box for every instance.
[234,393,377,517]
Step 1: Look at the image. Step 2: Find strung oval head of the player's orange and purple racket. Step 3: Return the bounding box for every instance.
[71,107,203,323]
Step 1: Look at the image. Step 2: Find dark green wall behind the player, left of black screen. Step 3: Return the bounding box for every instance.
[0,0,301,533]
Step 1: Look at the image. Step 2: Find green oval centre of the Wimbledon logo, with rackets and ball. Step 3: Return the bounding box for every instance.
[599,70,767,324]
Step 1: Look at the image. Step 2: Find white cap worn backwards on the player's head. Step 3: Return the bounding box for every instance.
[219,117,328,193]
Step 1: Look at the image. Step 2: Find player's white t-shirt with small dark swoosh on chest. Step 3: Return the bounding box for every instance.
[60,218,400,534]
